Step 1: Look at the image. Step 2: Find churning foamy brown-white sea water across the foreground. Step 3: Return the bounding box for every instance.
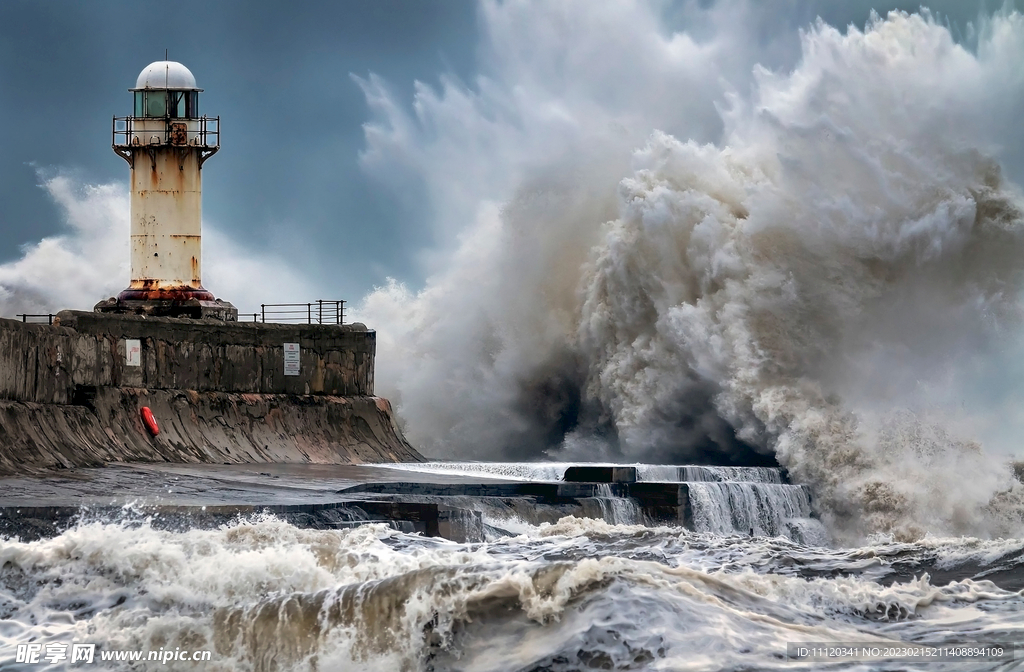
[0,464,1024,672]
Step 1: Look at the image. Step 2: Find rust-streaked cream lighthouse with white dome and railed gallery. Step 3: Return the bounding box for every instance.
[95,60,238,321]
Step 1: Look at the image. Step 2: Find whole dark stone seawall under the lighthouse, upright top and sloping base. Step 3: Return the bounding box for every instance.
[0,311,422,474]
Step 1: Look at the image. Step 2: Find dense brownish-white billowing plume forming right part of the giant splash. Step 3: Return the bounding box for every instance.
[579,13,1024,536]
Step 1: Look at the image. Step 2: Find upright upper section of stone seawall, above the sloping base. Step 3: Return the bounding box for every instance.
[0,310,377,404]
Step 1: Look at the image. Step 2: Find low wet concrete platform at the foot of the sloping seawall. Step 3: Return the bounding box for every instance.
[0,463,720,542]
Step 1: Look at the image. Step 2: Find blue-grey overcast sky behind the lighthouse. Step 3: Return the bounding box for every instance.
[0,0,1007,301]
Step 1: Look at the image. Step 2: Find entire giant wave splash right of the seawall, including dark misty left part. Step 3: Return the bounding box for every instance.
[362,3,1024,537]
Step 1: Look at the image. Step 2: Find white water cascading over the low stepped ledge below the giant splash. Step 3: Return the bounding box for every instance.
[348,462,827,543]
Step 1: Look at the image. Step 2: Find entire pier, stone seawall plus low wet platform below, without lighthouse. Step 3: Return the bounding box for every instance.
[0,311,815,542]
